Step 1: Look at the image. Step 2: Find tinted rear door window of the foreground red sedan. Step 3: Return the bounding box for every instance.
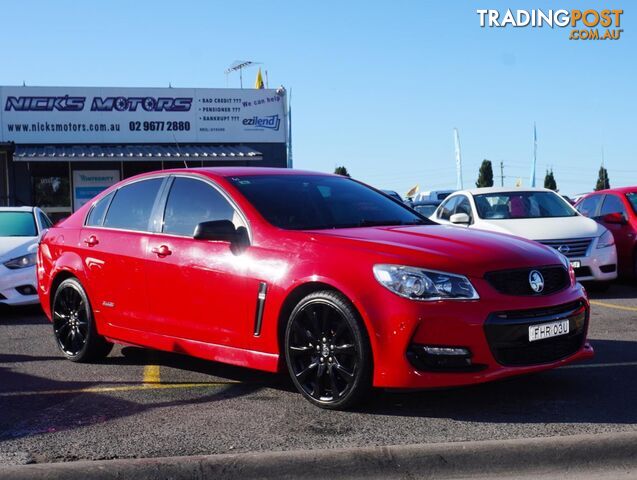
[104,178,164,231]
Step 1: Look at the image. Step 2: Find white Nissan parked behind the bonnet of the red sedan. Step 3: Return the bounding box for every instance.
[431,187,617,282]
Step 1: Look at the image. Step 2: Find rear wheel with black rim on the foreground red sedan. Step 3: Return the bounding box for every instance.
[51,278,113,362]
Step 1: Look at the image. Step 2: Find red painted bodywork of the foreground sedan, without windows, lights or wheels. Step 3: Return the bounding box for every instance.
[38,168,593,388]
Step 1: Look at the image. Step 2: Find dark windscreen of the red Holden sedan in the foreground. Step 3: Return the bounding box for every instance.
[230,175,433,230]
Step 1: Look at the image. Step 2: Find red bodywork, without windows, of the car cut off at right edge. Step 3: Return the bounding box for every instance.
[575,187,637,277]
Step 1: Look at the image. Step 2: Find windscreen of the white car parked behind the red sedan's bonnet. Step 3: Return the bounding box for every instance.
[474,191,577,220]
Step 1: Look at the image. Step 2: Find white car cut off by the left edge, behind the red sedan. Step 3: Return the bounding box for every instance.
[0,207,51,305]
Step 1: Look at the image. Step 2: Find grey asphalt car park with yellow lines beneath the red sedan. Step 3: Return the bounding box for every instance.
[0,283,637,465]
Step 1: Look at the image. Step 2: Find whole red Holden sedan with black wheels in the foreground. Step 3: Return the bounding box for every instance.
[38,168,593,409]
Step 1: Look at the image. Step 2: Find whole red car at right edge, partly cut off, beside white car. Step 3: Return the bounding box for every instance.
[575,187,637,278]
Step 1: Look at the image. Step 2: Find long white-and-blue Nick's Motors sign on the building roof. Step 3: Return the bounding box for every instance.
[0,87,287,144]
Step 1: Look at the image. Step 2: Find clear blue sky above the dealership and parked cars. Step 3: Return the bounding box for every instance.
[0,0,637,194]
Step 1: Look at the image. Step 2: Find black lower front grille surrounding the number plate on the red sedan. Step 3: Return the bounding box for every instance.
[484,302,588,366]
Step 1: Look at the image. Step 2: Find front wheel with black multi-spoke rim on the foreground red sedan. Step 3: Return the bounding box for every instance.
[284,290,372,410]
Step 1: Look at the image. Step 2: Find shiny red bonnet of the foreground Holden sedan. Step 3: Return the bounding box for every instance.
[312,225,562,276]
